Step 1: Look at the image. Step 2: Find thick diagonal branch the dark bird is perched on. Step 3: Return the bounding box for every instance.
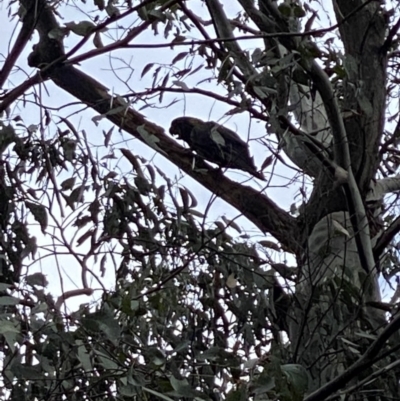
[18,0,300,254]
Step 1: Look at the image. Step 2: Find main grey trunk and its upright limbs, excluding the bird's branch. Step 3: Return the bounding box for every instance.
[245,0,400,400]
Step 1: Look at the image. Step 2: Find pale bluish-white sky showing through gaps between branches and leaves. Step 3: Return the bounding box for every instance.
[0,1,394,308]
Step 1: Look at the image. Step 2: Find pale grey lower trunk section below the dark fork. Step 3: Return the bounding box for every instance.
[289,212,400,400]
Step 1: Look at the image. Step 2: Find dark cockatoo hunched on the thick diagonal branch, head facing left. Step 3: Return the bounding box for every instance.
[169,117,265,180]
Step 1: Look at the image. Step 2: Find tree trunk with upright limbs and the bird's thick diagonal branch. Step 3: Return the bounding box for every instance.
[9,0,400,400]
